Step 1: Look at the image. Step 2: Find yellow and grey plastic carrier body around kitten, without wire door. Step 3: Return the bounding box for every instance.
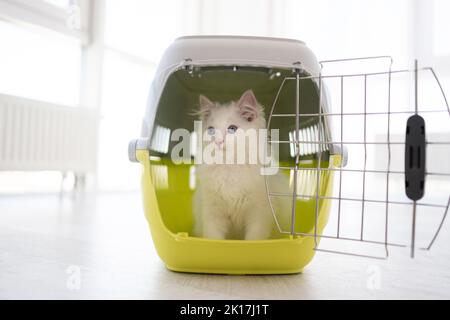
[129,36,340,274]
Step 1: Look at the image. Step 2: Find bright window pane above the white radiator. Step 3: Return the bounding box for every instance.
[0,20,81,106]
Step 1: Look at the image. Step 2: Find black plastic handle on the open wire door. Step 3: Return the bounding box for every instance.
[405,114,426,201]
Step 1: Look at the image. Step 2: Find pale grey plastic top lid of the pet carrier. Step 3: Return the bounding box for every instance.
[141,35,320,137]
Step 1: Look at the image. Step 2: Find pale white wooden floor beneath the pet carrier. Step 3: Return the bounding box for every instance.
[0,193,450,299]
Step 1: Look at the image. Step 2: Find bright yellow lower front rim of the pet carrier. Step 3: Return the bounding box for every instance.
[136,150,332,274]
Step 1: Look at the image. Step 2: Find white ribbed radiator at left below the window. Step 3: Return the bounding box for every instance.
[0,94,98,175]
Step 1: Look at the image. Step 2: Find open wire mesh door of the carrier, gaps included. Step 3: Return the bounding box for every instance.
[266,56,450,259]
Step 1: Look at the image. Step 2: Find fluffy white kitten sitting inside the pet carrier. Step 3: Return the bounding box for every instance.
[193,90,289,240]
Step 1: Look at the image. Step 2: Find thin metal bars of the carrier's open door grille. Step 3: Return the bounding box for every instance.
[265,56,450,259]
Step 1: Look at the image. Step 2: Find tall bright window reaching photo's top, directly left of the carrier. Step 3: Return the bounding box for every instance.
[98,0,191,190]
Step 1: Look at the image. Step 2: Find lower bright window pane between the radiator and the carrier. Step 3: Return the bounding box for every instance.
[98,50,154,189]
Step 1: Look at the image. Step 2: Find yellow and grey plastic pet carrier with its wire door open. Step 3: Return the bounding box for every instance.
[129,36,450,274]
